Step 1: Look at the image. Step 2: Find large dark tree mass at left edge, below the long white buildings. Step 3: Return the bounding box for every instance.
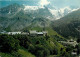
[0,34,19,52]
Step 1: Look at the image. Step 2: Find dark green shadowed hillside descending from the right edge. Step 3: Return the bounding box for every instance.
[52,9,80,38]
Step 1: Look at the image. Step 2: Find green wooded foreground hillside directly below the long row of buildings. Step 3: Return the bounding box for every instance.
[0,34,66,57]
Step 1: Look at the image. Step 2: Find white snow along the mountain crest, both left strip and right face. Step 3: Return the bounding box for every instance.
[24,5,79,20]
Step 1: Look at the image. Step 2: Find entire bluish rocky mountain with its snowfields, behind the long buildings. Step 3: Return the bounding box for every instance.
[0,4,77,31]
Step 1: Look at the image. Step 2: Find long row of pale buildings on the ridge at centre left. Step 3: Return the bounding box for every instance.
[0,30,48,36]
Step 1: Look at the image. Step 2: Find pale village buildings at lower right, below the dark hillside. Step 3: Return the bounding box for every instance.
[58,39,78,56]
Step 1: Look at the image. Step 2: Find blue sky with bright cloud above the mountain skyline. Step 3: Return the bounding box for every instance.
[0,0,80,8]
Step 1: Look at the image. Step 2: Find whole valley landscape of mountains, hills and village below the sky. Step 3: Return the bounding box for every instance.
[0,3,80,57]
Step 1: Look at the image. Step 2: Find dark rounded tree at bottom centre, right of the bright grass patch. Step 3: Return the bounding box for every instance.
[35,45,50,57]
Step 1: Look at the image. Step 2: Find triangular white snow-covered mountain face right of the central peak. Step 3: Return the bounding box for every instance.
[48,6,79,19]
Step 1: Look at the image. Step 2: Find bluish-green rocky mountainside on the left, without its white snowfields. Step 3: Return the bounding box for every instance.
[0,4,79,31]
